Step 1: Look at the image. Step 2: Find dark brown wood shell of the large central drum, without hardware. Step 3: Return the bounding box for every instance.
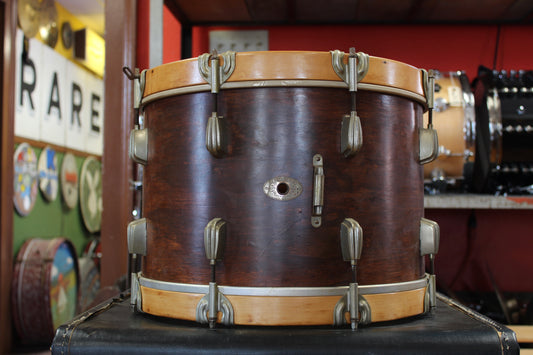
[143,88,423,287]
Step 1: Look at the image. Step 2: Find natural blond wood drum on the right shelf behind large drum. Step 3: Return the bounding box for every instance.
[424,71,476,181]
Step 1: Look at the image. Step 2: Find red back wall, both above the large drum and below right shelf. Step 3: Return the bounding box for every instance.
[149,18,533,292]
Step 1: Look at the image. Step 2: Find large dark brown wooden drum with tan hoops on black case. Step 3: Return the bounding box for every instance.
[128,51,438,326]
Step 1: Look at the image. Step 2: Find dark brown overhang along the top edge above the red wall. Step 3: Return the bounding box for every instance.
[165,0,533,25]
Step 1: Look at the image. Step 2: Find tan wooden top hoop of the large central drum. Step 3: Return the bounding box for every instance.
[142,51,426,105]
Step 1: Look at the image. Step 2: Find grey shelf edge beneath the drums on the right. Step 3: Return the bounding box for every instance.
[424,194,533,210]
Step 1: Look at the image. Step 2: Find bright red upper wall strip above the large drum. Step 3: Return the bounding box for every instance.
[193,25,533,78]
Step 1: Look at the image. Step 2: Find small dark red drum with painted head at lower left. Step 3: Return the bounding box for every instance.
[11,238,79,343]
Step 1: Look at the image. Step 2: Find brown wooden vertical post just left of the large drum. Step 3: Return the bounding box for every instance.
[101,0,137,286]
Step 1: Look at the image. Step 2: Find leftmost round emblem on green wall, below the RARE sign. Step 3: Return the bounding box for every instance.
[13,143,38,216]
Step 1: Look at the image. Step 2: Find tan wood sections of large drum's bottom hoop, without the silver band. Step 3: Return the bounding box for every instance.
[141,287,426,326]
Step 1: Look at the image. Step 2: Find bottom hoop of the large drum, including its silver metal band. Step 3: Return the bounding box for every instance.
[132,274,429,326]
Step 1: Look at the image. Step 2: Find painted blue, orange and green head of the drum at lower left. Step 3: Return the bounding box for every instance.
[50,243,78,329]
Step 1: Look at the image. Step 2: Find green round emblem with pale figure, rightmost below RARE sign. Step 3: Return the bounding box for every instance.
[80,157,102,233]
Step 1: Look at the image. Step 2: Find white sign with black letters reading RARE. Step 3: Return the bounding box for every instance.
[15,30,104,155]
